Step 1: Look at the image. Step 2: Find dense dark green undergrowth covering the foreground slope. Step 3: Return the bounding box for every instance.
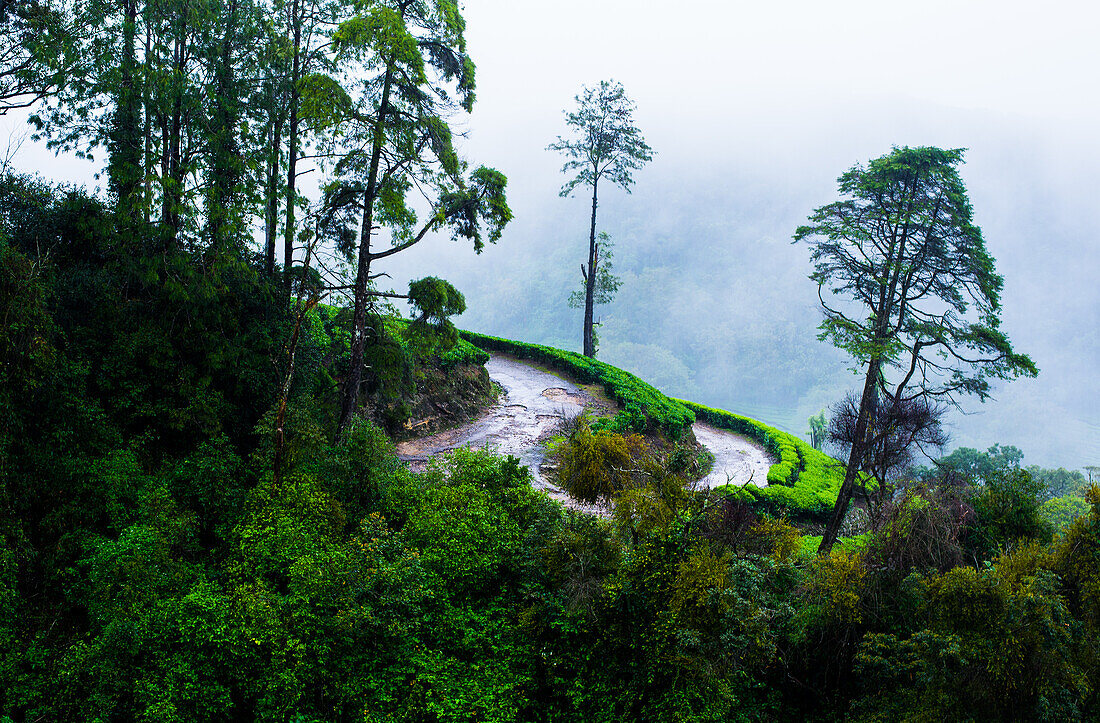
[0,171,1100,721]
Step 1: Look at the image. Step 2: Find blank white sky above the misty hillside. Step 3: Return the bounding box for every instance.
[465,0,1100,145]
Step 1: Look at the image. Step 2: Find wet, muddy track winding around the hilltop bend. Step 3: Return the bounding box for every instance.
[397,353,774,504]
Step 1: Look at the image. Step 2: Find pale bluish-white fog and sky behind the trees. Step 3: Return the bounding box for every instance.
[4,0,1100,468]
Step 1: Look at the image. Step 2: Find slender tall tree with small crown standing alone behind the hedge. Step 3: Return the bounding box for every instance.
[548,80,653,357]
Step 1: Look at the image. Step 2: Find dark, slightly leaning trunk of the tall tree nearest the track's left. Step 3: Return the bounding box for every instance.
[337,68,393,439]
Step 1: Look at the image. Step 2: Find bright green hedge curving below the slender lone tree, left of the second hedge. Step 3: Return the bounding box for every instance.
[462,331,695,439]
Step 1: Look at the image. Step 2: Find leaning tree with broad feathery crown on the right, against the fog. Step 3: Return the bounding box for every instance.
[794,147,1038,554]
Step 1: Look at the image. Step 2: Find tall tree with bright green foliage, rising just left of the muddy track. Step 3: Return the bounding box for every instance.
[300,0,512,436]
